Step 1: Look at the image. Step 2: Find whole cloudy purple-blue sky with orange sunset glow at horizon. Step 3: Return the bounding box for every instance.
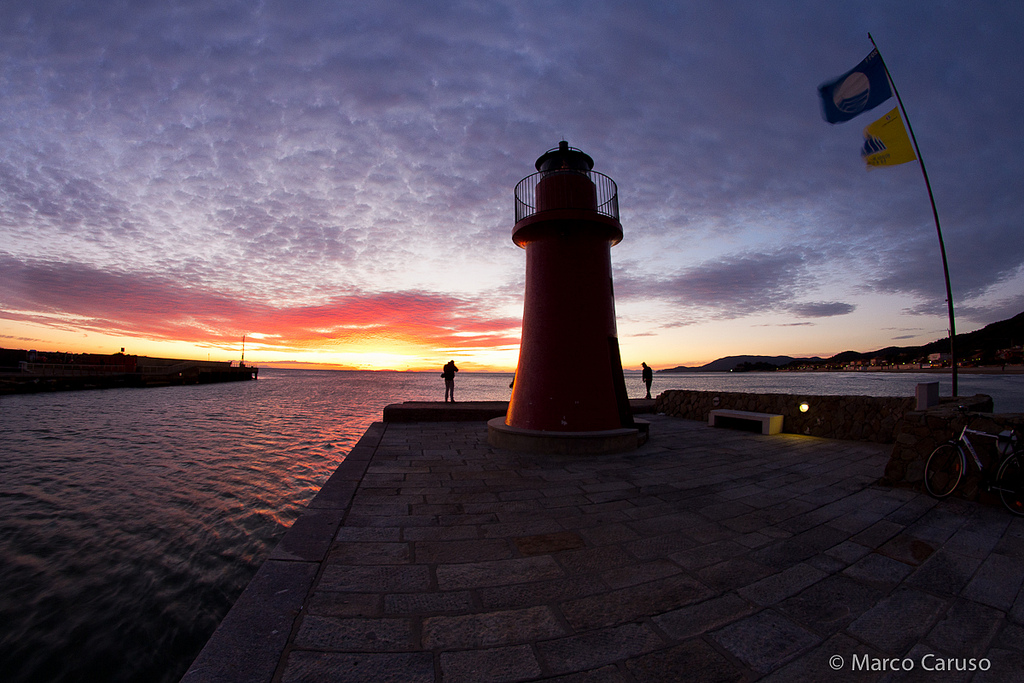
[0,0,1024,370]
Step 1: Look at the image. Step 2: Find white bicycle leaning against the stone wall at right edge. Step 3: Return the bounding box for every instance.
[925,407,1024,516]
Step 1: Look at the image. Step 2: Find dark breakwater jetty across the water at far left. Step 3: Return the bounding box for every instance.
[0,349,259,394]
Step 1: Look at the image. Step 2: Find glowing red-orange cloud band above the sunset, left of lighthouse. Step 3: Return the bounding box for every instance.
[0,256,520,348]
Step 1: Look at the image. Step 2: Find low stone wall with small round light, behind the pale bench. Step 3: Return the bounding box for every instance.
[655,389,915,443]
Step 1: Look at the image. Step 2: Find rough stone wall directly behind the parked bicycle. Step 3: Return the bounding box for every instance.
[882,396,1024,500]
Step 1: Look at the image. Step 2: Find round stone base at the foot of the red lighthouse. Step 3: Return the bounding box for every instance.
[487,417,650,456]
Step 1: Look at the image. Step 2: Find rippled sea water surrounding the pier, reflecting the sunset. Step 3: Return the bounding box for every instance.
[0,369,1024,681]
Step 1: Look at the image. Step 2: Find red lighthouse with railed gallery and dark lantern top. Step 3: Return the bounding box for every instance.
[488,141,646,453]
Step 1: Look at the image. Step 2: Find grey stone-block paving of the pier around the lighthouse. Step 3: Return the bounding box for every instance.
[183,416,1024,683]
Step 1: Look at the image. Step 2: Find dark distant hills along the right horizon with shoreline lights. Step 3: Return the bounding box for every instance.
[657,312,1024,373]
